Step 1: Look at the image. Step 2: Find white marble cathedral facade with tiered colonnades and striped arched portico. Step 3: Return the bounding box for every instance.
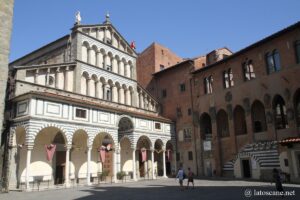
[5,15,176,190]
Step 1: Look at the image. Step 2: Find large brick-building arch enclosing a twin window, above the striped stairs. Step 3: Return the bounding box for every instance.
[273,95,288,129]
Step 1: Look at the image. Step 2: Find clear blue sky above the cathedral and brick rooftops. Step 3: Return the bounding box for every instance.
[10,0,300,61]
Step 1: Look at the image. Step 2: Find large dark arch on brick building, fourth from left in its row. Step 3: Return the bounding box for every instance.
[251,101,267,133]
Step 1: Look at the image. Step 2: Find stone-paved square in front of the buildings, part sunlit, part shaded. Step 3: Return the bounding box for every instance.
[0,179,300,200]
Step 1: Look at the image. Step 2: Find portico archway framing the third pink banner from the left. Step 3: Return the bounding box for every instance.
[137,136,152,178]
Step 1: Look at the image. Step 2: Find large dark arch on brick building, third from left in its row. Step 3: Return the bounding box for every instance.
[233,106,247,135]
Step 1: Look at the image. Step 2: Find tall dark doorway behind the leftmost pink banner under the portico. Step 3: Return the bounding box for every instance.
[55,151,66,184]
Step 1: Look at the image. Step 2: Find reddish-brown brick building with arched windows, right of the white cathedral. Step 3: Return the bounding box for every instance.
[137,22,300,181]
